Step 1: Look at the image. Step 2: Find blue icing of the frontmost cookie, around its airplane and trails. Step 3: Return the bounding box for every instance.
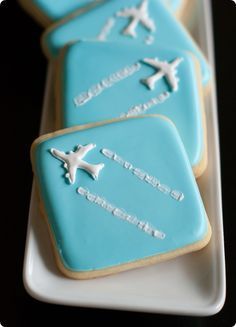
[33,117,207,271]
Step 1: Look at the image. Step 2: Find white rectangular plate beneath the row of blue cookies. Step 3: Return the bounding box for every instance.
[24,0,225,316]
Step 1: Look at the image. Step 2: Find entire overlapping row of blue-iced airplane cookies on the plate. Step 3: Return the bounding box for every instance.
[21,0,211,279]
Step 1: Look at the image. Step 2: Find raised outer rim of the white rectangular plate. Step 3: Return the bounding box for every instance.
[23,0,226,316]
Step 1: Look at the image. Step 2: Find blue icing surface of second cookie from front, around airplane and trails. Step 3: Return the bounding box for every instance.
[59,42,205,166]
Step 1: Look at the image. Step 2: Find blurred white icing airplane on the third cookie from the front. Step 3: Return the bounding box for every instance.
[116,0,155,37]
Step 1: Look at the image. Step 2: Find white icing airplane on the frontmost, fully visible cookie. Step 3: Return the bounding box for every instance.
[51,144,104,184]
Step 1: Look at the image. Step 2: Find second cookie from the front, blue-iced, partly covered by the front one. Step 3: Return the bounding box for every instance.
[55,42,207,176]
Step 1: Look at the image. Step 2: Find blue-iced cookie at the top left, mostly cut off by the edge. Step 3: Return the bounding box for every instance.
[18,0,103,26]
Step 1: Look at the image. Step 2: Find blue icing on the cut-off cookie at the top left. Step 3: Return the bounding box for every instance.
[28,0,102,21]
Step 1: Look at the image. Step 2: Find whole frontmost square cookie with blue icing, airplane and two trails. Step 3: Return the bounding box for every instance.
[32,116,211,279]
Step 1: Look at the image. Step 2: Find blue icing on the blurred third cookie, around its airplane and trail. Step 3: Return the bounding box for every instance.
[43,0,210,84]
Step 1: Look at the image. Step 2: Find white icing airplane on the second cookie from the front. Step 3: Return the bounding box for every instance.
[141,58,183,91]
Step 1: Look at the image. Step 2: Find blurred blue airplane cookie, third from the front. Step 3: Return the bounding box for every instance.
[42,0,210,85]
